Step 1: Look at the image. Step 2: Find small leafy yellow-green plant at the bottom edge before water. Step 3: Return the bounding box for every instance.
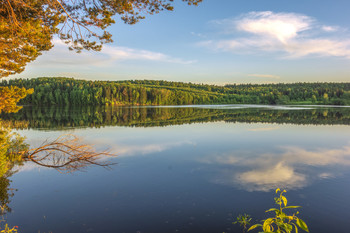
[248,189,309,233]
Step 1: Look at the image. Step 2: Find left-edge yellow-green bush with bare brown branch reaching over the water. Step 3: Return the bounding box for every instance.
[0,121,116,218]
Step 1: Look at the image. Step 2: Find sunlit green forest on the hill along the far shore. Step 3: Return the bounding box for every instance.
[0,78,350,106]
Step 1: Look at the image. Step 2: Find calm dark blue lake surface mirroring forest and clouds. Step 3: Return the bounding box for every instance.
[3,105,350,233]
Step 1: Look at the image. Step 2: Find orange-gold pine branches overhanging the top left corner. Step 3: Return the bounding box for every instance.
[0,0,202,78]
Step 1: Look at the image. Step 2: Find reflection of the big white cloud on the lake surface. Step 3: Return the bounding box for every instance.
[201,146,350,192]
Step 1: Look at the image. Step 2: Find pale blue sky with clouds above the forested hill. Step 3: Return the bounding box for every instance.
[8,0,350,85]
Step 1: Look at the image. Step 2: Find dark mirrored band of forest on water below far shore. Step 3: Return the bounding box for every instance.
[1,106,350,130]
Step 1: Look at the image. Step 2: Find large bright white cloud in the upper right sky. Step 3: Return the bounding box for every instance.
[199,11,350,59]
